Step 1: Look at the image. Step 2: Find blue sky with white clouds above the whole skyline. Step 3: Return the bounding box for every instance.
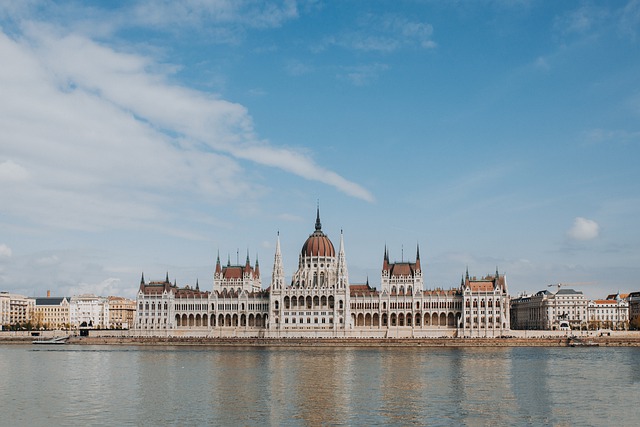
[0,0,640,298]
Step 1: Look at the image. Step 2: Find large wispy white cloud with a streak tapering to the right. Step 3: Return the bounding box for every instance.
[0,22,373,234]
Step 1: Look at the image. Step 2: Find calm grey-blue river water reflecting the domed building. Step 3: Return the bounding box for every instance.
[0,345,640,426]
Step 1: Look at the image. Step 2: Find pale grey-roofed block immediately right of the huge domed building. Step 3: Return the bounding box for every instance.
[511,288,587,330]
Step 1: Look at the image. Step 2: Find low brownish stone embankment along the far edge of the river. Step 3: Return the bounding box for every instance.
[0,336,640,347]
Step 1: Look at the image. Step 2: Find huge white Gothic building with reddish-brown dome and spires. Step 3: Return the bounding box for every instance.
[132,210,510,338]
